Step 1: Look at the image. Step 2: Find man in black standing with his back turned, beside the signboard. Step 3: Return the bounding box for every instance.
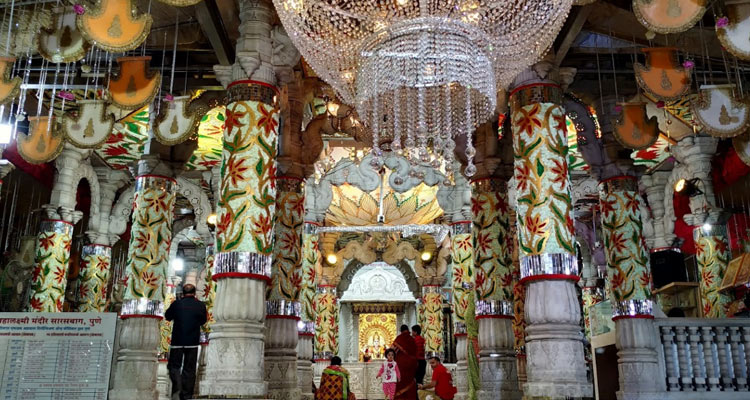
[164,284,208,400]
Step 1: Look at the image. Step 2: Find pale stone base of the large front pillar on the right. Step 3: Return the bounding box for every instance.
[524,280,593,399]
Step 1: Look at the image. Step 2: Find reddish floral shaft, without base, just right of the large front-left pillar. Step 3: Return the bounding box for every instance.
[267,177,305,301]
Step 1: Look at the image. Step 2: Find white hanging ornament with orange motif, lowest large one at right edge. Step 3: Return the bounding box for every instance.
[692,85,750,138]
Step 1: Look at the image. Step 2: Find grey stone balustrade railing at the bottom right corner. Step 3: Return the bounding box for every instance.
[654,318,750,399]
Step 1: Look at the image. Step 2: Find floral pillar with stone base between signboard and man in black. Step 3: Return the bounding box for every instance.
[109,157,176,400]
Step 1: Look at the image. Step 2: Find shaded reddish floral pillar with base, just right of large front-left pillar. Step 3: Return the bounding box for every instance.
[265,176,305,400]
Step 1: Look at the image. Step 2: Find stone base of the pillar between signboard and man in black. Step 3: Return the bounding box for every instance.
[109,317,159,400]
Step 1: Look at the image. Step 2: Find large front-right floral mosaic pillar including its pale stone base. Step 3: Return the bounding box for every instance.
[510,74,592,398]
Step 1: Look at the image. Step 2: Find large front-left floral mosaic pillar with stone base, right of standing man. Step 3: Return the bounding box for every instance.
[200,80,279,397]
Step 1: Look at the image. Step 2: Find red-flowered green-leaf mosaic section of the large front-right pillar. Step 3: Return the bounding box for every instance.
[512,103,575,257]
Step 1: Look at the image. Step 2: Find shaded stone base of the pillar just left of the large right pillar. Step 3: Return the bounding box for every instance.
[478,316,522,400]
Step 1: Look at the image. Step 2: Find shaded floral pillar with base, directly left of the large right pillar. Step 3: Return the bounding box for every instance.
[471,177,521,399]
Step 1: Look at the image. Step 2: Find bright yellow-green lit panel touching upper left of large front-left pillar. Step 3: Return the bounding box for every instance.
[185,106,226,170]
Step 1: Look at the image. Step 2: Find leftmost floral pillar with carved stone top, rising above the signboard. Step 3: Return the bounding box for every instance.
[27,144,89,312]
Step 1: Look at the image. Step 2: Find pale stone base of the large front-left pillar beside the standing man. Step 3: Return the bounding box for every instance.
[200,278,266,399]
